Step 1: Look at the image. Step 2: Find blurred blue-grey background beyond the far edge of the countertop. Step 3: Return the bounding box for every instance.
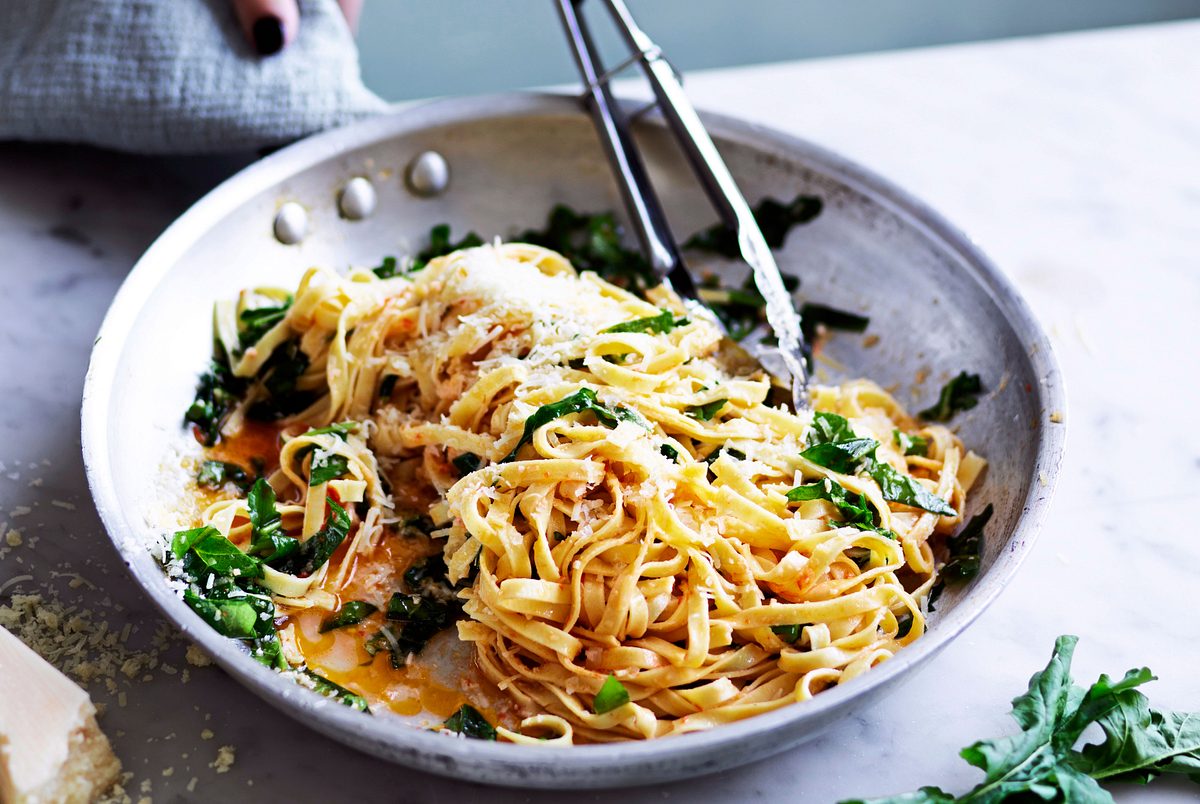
[359,0,1200,101]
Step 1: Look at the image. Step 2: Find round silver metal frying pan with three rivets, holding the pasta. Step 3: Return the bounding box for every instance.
[83,94,1064,788]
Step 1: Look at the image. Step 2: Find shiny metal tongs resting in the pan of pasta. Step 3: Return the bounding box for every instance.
[556,0,810,410]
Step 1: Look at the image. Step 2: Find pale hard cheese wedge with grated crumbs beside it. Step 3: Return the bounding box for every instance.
[0,628,121,804]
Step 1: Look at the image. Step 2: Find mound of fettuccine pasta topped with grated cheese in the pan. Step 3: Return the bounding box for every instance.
[176,244,984,745]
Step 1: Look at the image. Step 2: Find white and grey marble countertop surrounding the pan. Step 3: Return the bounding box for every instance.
[0,23,1200,804]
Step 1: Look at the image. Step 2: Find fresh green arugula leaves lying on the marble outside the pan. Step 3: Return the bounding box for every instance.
[846,636,1200,804]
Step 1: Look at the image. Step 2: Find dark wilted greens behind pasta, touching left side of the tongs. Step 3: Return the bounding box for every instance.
[514,204,660,295]
